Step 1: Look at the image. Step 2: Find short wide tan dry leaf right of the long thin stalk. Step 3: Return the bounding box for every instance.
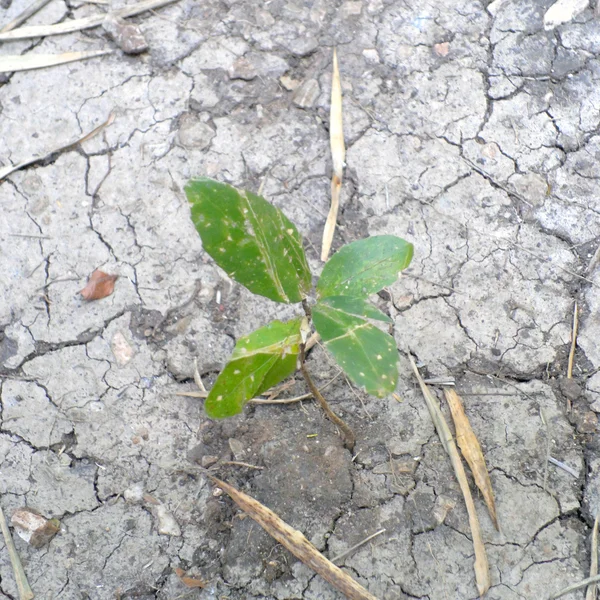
[444,388,500,531]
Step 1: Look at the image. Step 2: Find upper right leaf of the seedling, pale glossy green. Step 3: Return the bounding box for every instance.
[317,235,413,298]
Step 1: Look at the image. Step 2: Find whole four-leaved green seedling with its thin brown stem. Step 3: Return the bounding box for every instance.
[185,179,413,446]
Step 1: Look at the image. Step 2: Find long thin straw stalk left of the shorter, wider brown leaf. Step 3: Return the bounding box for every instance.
[408,353,491,596]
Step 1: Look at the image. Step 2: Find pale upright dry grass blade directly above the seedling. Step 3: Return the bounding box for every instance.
[321,49,346,262]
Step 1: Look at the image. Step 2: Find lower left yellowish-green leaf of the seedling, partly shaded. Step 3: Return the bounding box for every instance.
[204,318,302,418]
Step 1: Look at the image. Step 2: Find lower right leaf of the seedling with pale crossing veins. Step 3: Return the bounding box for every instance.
[312,298,398,398]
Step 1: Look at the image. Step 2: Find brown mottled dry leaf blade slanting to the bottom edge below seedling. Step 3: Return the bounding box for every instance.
[209,475,377,600]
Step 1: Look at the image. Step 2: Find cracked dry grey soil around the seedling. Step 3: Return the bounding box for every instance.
[0,0,600,600]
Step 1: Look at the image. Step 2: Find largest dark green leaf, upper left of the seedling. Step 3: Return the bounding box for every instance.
[185,179,311,303]
